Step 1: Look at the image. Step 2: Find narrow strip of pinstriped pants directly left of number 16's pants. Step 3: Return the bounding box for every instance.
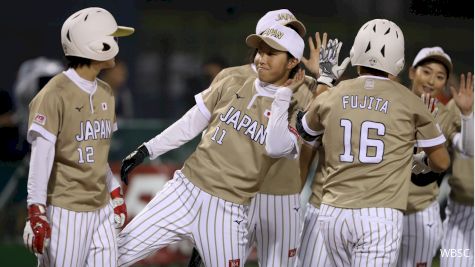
[297,203,330,267]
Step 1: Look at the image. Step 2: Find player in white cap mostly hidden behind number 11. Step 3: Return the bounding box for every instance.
[184,9,318,266]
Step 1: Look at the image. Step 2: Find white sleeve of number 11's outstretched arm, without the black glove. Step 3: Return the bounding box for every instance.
[145,105,209,159]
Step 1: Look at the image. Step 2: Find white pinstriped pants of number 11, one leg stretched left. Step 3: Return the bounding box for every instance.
[117,170,248,267]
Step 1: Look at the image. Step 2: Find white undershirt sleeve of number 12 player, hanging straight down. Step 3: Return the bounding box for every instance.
[26,134,55,205]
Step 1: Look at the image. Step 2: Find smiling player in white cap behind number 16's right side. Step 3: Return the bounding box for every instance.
[397,47,462,266]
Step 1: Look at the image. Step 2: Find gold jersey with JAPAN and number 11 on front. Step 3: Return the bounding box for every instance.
[182,76,302,204]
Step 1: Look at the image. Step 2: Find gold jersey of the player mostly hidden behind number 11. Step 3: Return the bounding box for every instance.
[211,64,316,195]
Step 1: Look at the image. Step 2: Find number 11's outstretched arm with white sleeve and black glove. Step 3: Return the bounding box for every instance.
[120,106,209,184]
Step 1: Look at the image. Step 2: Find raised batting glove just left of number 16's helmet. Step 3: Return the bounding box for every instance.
[317,39,350,87]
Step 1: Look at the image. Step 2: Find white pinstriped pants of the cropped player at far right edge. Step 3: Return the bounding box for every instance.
[440,197,474,267]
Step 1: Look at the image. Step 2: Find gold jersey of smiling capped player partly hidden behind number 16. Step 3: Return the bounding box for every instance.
[406,102,455,214]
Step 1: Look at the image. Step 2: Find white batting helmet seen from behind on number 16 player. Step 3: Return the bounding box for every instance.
[350,19,404,76]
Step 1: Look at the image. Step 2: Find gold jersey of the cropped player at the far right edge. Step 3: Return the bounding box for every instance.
[447,99,474,206]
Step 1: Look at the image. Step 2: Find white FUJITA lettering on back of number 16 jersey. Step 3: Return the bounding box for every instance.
[341,95,389,114]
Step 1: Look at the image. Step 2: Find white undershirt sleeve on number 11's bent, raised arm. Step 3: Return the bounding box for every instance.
[265,87,299,158]
